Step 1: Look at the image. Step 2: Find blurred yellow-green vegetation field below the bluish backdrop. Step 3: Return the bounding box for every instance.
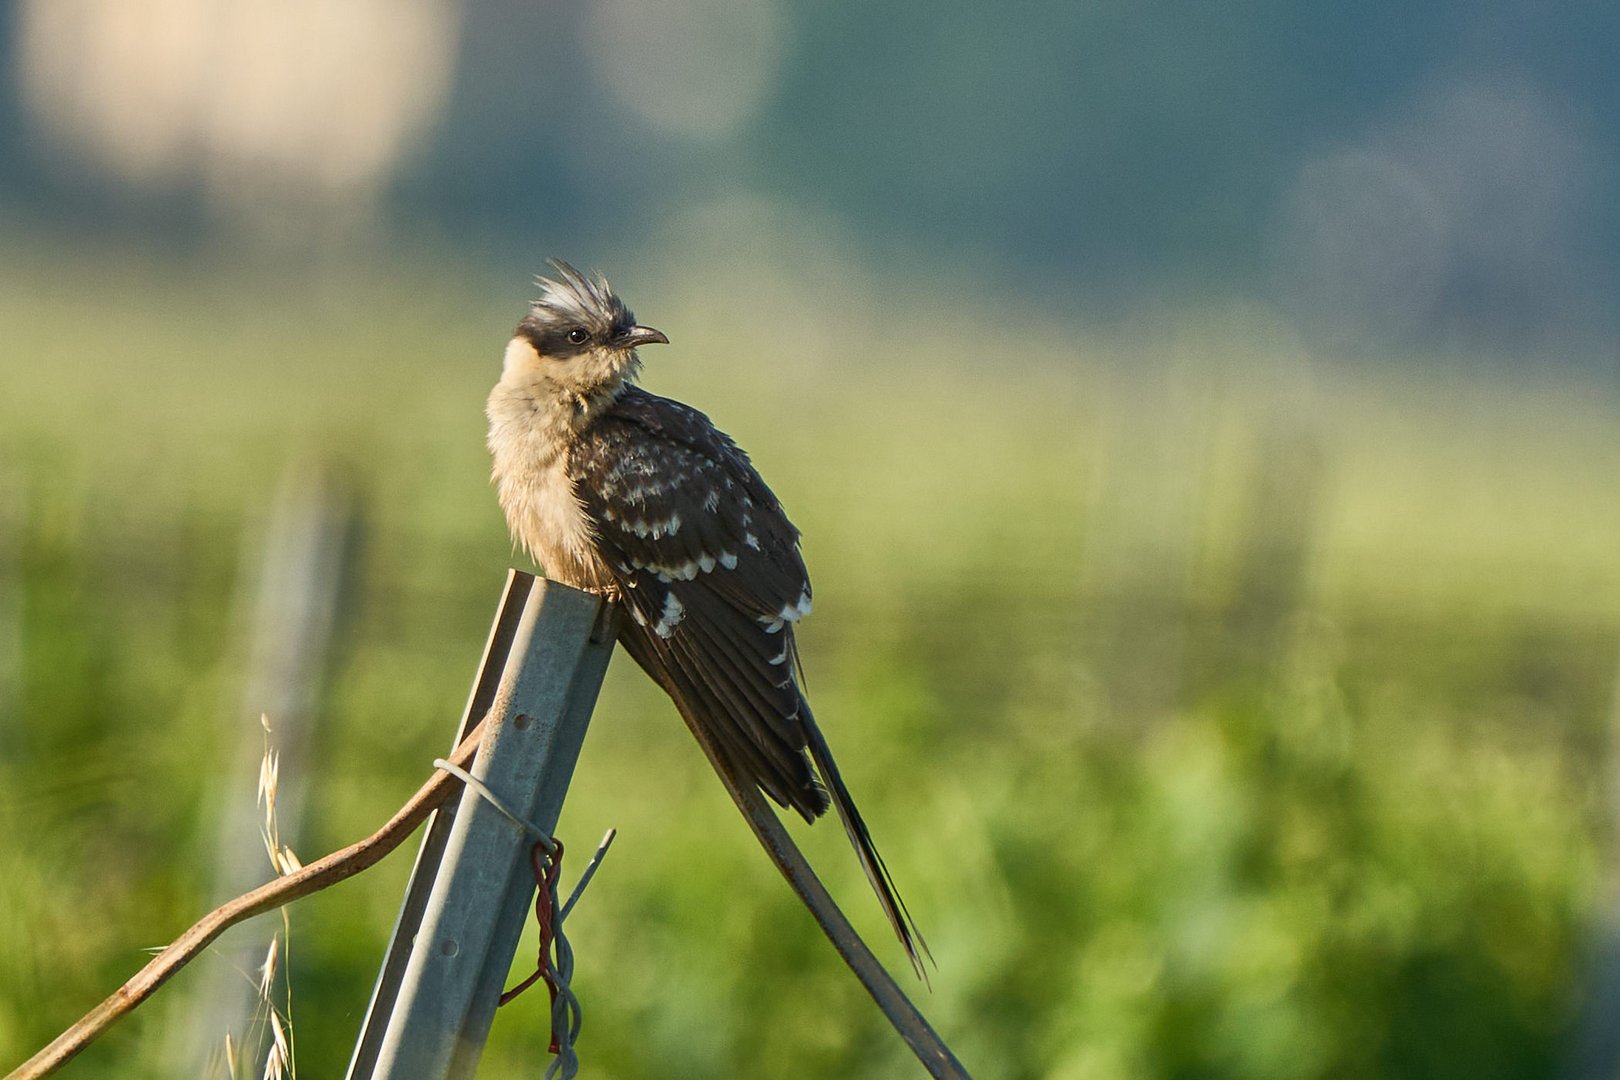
[0,249,1620,1080]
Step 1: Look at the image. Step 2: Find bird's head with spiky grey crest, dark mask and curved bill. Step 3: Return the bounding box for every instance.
[502,259,669,405]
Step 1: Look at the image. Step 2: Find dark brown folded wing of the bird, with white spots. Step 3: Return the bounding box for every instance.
[569,390,828,819]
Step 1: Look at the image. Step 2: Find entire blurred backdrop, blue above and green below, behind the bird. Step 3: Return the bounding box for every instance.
[0,0,1620,1080]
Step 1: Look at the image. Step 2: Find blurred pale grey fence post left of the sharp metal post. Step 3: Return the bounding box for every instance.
[168,463,360,1077]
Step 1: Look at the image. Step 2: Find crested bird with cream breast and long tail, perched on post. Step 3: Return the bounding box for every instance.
[486,259,927,976]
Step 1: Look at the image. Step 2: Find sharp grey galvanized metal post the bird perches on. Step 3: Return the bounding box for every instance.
[348,572,612,1080]
